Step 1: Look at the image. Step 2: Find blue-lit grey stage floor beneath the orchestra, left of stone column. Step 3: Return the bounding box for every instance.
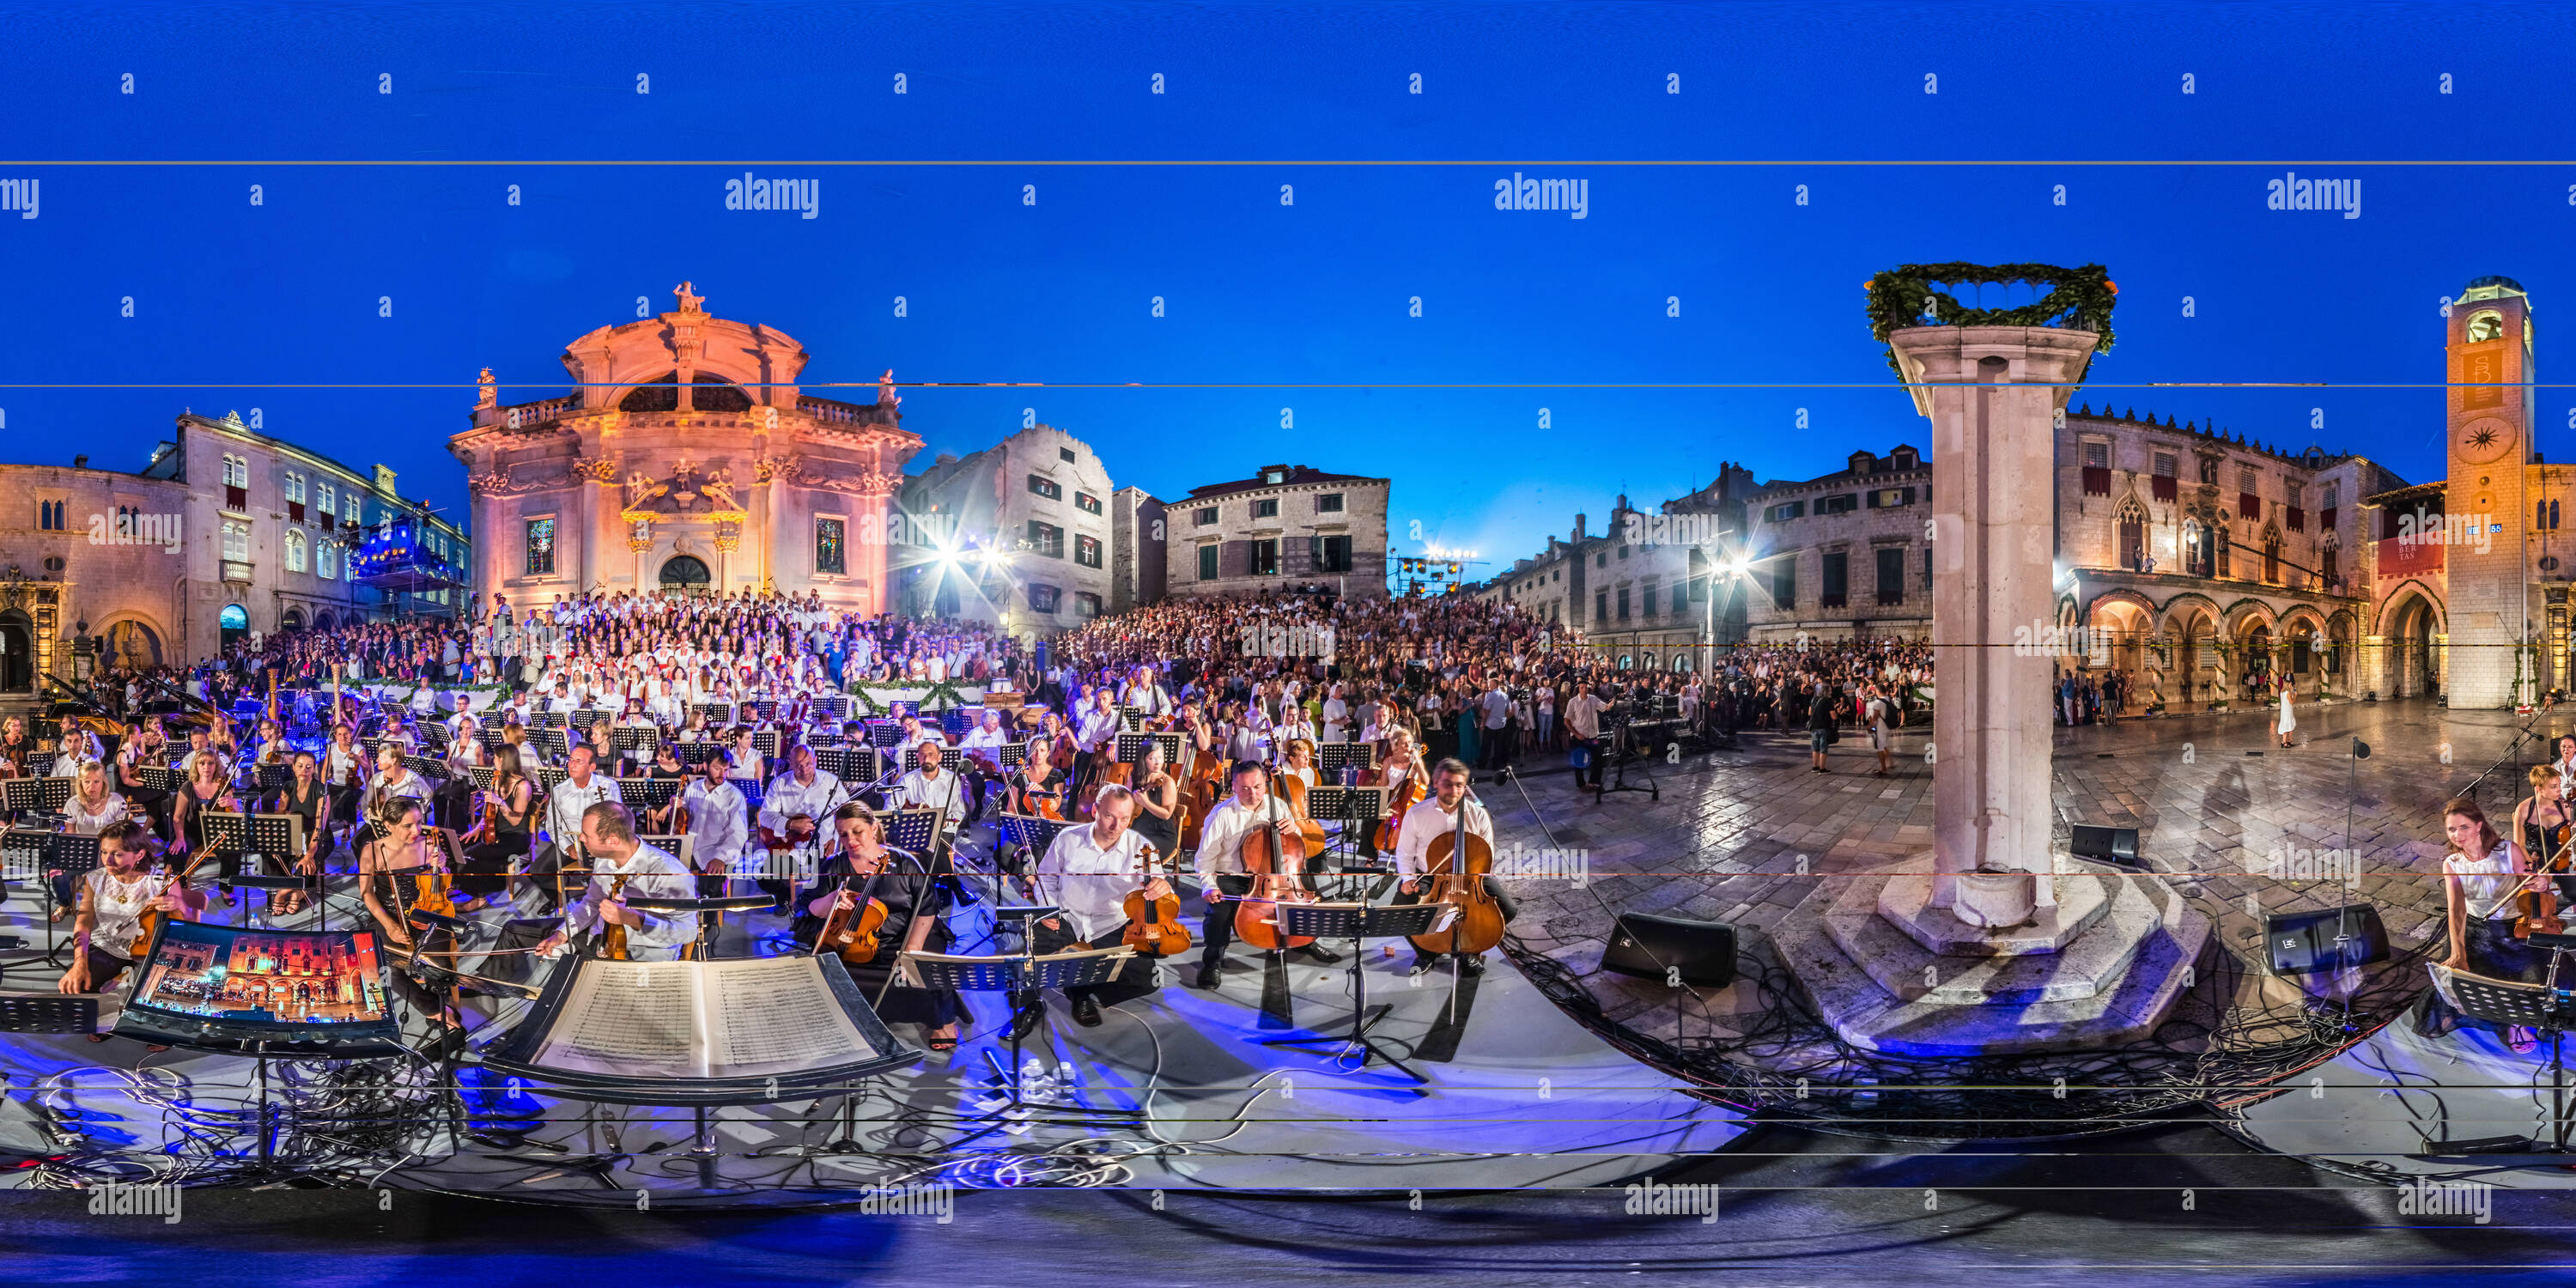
[0,850,1744,1208]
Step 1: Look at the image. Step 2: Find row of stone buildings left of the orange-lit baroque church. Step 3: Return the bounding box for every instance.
[0,410,471,706]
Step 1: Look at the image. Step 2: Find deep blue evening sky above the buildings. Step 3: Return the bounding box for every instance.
[0,3,2576,572]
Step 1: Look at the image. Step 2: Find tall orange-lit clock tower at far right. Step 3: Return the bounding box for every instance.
[2442,278,2543,708]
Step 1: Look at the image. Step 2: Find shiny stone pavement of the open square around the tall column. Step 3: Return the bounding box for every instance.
[1476,701,2545,1092]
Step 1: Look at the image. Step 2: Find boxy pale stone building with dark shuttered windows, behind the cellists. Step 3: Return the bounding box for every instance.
[1164,464,1388,598]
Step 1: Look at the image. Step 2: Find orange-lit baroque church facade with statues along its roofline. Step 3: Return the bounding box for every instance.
[448,283,922,613]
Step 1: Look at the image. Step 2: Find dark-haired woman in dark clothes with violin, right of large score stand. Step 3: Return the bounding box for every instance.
[793,801,966,1051]
